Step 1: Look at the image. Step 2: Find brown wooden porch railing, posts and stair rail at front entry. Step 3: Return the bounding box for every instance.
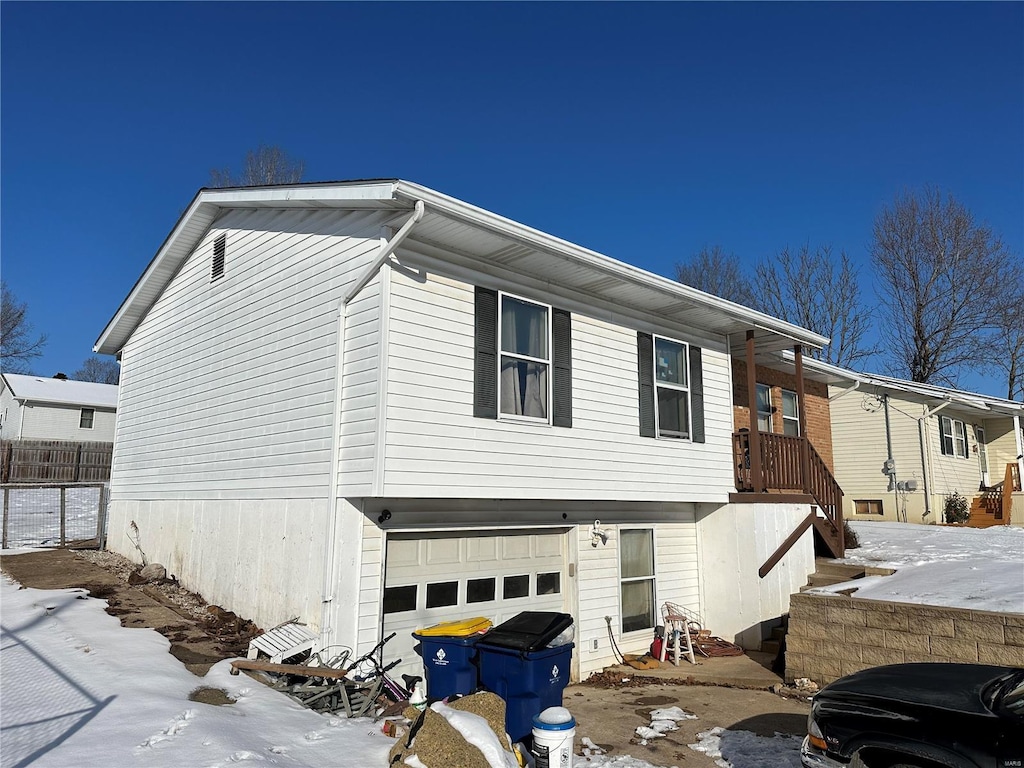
[732,332,846,579]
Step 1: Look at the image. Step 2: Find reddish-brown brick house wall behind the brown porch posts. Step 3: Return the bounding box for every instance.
[732,358,836,472]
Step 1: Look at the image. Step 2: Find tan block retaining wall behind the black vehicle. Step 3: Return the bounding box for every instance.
[785,593,1024,685]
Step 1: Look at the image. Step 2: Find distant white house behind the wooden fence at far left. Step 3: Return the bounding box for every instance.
[0,374,118,442]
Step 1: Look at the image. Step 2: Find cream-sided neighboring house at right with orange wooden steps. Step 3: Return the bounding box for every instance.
[806,360,1024,525]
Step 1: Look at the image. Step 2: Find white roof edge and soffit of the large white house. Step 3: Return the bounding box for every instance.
[93,179,828,354]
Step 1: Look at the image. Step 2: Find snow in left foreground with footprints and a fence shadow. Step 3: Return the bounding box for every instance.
[0,577,394,768]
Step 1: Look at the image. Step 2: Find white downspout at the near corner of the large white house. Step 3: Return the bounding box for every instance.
[321,200,425,650]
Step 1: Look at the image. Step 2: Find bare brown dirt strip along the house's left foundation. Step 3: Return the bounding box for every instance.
[0,550,260,676]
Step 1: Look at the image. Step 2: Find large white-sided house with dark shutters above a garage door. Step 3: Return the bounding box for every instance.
[95,180,842,677]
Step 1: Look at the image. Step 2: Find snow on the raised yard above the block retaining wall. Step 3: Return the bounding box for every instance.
[812,522,1024,613]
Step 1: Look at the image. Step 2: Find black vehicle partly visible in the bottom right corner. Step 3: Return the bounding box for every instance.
[801,664,1024,768]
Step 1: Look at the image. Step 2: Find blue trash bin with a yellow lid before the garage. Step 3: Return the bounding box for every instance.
[413,616,490,701]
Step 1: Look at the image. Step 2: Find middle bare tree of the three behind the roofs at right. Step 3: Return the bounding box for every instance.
[757,244,878,368]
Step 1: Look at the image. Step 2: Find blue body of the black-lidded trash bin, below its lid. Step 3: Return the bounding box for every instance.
[476,637,573,742]
